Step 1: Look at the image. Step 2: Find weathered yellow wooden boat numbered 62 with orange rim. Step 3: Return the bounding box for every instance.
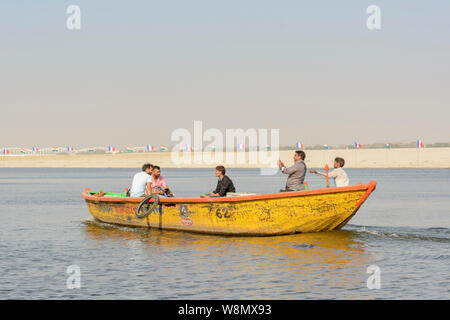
[82,181,376,236]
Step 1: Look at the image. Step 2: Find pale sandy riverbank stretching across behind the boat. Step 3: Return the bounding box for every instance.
[0,148,450,168]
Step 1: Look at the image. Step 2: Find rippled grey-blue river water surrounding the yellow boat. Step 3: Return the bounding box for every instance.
[0,169,450,299]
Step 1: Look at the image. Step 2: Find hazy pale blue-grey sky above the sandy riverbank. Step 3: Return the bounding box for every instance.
[0,0,450,147]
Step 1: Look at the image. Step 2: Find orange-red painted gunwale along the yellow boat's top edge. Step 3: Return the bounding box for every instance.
[81,181,376,204]
